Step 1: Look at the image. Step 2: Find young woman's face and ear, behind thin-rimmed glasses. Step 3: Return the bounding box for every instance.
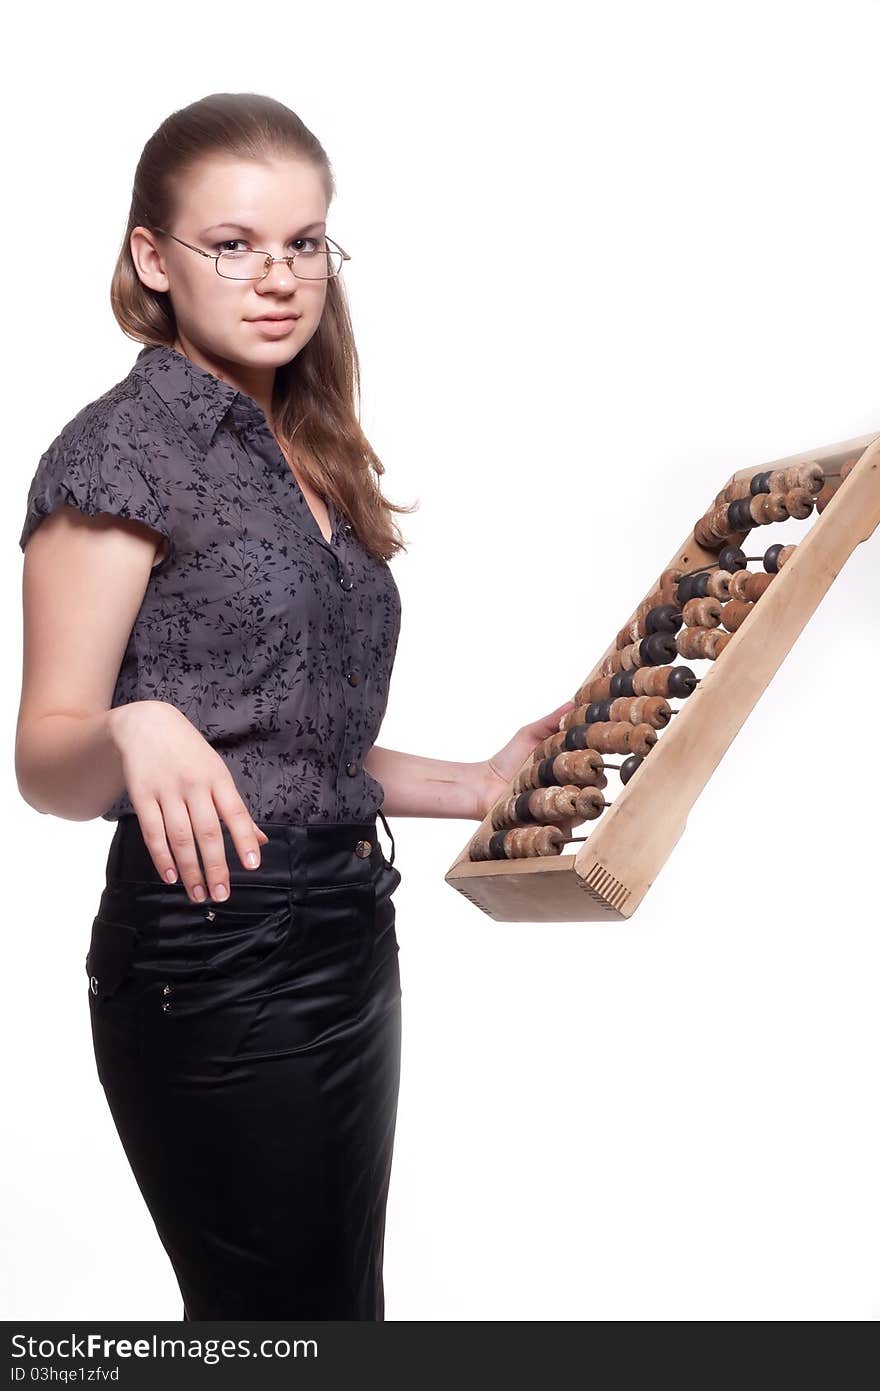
[131,156,327,395]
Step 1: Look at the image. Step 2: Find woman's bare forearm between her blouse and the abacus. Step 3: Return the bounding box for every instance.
[363,744,485,821]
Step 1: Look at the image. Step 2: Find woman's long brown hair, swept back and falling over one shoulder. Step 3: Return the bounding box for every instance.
[110,92,416,561]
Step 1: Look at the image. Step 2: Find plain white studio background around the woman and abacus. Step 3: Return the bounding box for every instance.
[0,0,880,1320]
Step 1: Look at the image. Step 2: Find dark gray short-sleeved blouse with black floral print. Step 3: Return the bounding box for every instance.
[19,346,400,825]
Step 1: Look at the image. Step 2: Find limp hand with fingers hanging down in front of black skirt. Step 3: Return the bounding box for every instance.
[110,700,268,903]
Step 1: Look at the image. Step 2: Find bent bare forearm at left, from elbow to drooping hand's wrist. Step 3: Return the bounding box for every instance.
[15,707,125,821]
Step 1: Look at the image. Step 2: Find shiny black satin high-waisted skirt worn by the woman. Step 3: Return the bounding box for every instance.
[86,814,400,1320]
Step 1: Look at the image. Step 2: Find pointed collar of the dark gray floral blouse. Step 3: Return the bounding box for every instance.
[132,344,266,453]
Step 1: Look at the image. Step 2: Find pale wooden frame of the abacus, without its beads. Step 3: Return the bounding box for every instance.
[446,434,880,922]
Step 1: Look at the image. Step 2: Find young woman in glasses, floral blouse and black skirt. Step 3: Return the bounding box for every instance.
[15,93,571,1320]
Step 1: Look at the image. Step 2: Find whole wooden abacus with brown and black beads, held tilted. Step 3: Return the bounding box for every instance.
[446,434,880,922]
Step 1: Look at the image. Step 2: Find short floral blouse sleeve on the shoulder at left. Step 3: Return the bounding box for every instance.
[18,406,174,555]
